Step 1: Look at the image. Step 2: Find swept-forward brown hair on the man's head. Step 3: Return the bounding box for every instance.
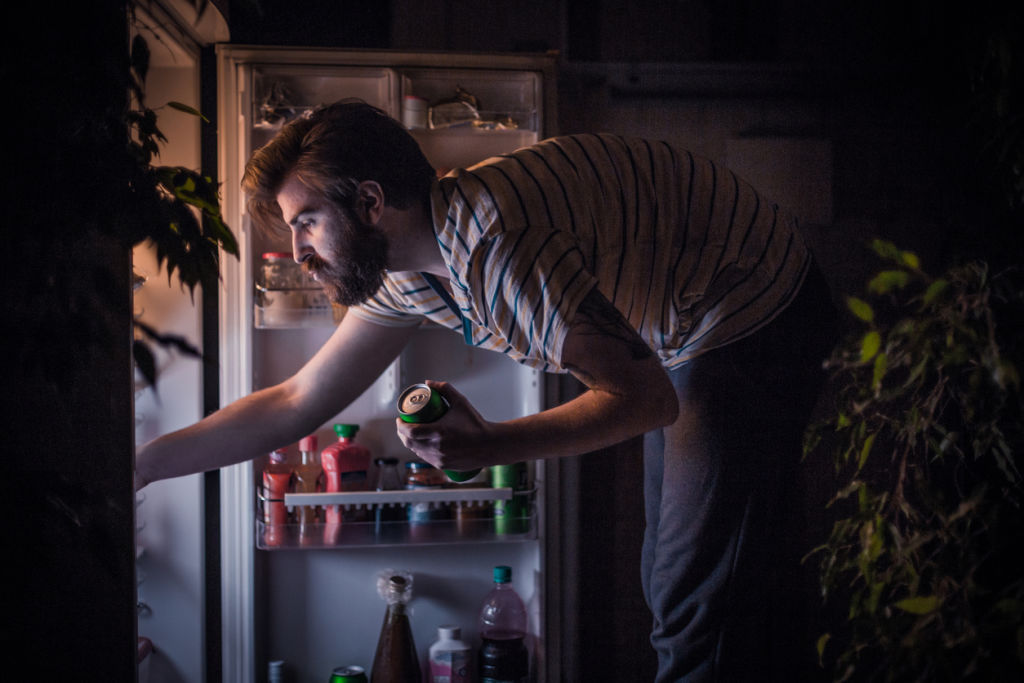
[242,100,435,229]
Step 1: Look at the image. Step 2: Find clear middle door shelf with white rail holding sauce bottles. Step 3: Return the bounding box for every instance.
[256,487,537,550]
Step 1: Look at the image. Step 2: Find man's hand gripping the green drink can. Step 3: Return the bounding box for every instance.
[395,380,501,471]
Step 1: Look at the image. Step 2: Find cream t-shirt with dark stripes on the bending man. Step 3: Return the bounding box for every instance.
[351,135,810,372]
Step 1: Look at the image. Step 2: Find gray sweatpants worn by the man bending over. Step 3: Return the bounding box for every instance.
[641,268,836,683]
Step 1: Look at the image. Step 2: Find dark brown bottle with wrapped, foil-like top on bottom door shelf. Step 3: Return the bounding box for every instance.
[370,572,421,683]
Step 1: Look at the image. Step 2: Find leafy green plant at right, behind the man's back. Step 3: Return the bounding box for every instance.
[806,241,1024,682]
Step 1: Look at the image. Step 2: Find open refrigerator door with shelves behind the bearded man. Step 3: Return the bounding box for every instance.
[208,44,559,683]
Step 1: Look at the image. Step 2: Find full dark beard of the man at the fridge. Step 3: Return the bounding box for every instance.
[305,220,388,306]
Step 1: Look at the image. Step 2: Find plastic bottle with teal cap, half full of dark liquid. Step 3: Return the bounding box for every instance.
[479,565,529,683]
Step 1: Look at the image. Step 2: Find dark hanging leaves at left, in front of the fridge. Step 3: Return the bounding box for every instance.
[126,31,239,385]
